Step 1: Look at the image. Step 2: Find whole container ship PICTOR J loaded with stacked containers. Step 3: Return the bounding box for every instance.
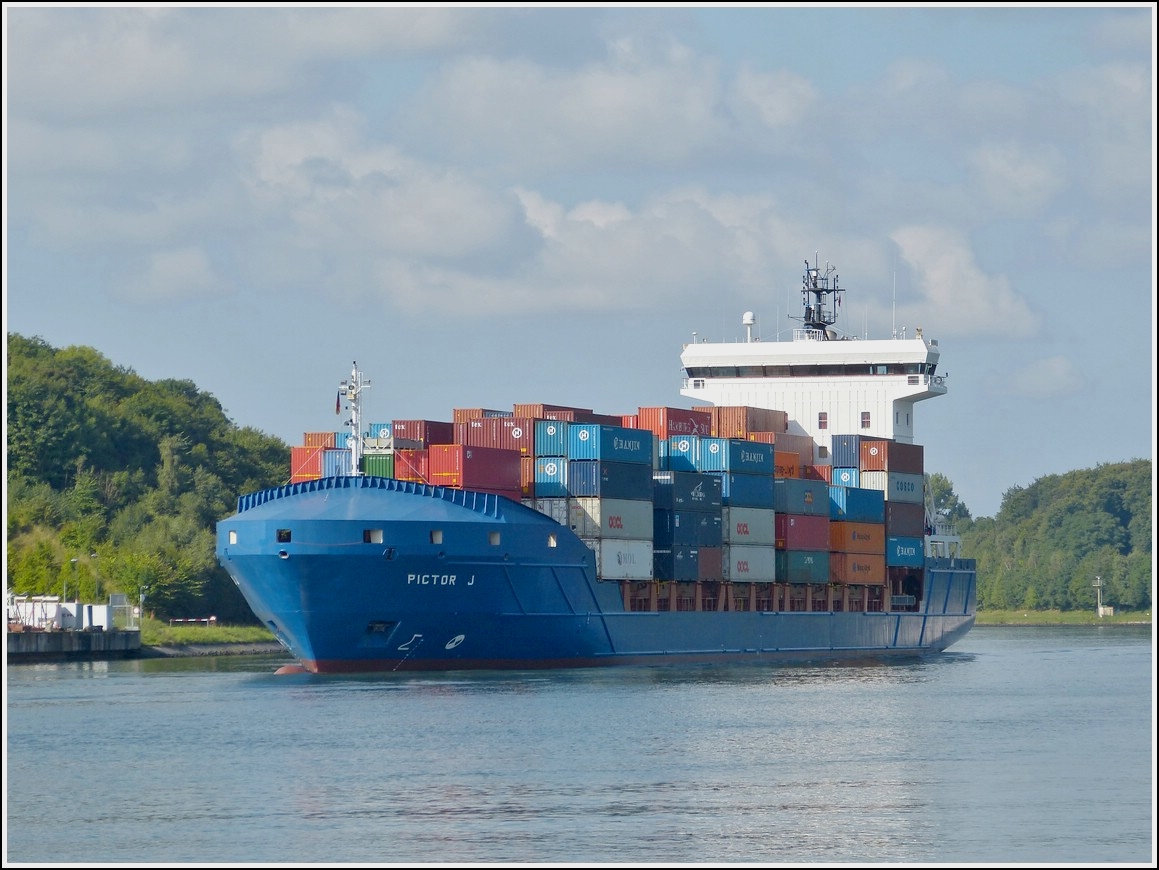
[217,261,976,673]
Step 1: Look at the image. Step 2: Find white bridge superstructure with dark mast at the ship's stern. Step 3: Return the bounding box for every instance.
[680,257,946,465]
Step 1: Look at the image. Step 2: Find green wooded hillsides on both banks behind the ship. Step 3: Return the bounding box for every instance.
[7,332,1152,624]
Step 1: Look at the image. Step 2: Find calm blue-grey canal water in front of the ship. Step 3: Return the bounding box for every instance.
[5,627,1156,865]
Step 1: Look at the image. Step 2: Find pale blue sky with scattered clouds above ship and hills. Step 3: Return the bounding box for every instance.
[3,3,1156,517]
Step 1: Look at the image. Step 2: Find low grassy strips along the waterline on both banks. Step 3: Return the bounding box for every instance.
[141,608,1151,656]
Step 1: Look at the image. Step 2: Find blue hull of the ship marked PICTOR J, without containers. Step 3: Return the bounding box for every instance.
[217,476,975,673]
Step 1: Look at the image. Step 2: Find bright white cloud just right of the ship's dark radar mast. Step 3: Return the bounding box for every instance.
[891,226,1038,338]
